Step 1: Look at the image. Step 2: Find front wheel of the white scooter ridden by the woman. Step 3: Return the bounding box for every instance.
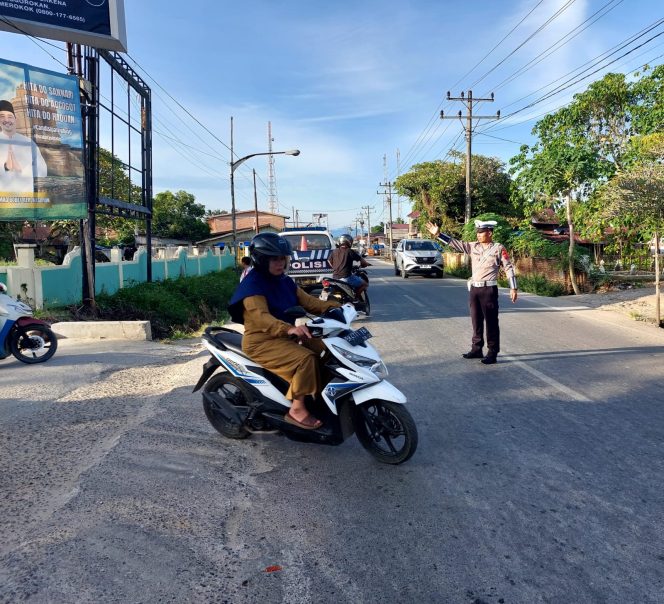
[355,400,417,465]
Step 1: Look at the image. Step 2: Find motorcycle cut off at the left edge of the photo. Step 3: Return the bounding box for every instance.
[0,283,58,364]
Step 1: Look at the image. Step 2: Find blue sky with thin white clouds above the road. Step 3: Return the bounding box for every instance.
[0,0,664,228]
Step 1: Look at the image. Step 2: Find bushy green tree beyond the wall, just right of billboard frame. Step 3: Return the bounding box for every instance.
[152,191,210,241]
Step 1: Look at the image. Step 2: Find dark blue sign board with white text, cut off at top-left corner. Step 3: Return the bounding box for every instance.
[0,0,127,52]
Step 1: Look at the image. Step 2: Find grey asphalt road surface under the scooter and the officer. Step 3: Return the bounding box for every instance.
[0,262,664,604]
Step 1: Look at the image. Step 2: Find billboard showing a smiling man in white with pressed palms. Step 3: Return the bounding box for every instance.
[0,60,87,220]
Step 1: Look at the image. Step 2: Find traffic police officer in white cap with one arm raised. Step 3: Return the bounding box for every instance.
[427,220,517,365]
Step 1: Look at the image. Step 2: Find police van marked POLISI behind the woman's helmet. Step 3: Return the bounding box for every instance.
[279,227,336,291]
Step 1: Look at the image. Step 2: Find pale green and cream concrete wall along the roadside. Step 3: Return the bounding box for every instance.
[0,245,234,308]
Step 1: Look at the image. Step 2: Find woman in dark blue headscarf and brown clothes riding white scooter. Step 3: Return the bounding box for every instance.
[228,233,339,430]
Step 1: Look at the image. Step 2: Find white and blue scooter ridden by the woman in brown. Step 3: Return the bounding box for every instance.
[194,304,418,464]
